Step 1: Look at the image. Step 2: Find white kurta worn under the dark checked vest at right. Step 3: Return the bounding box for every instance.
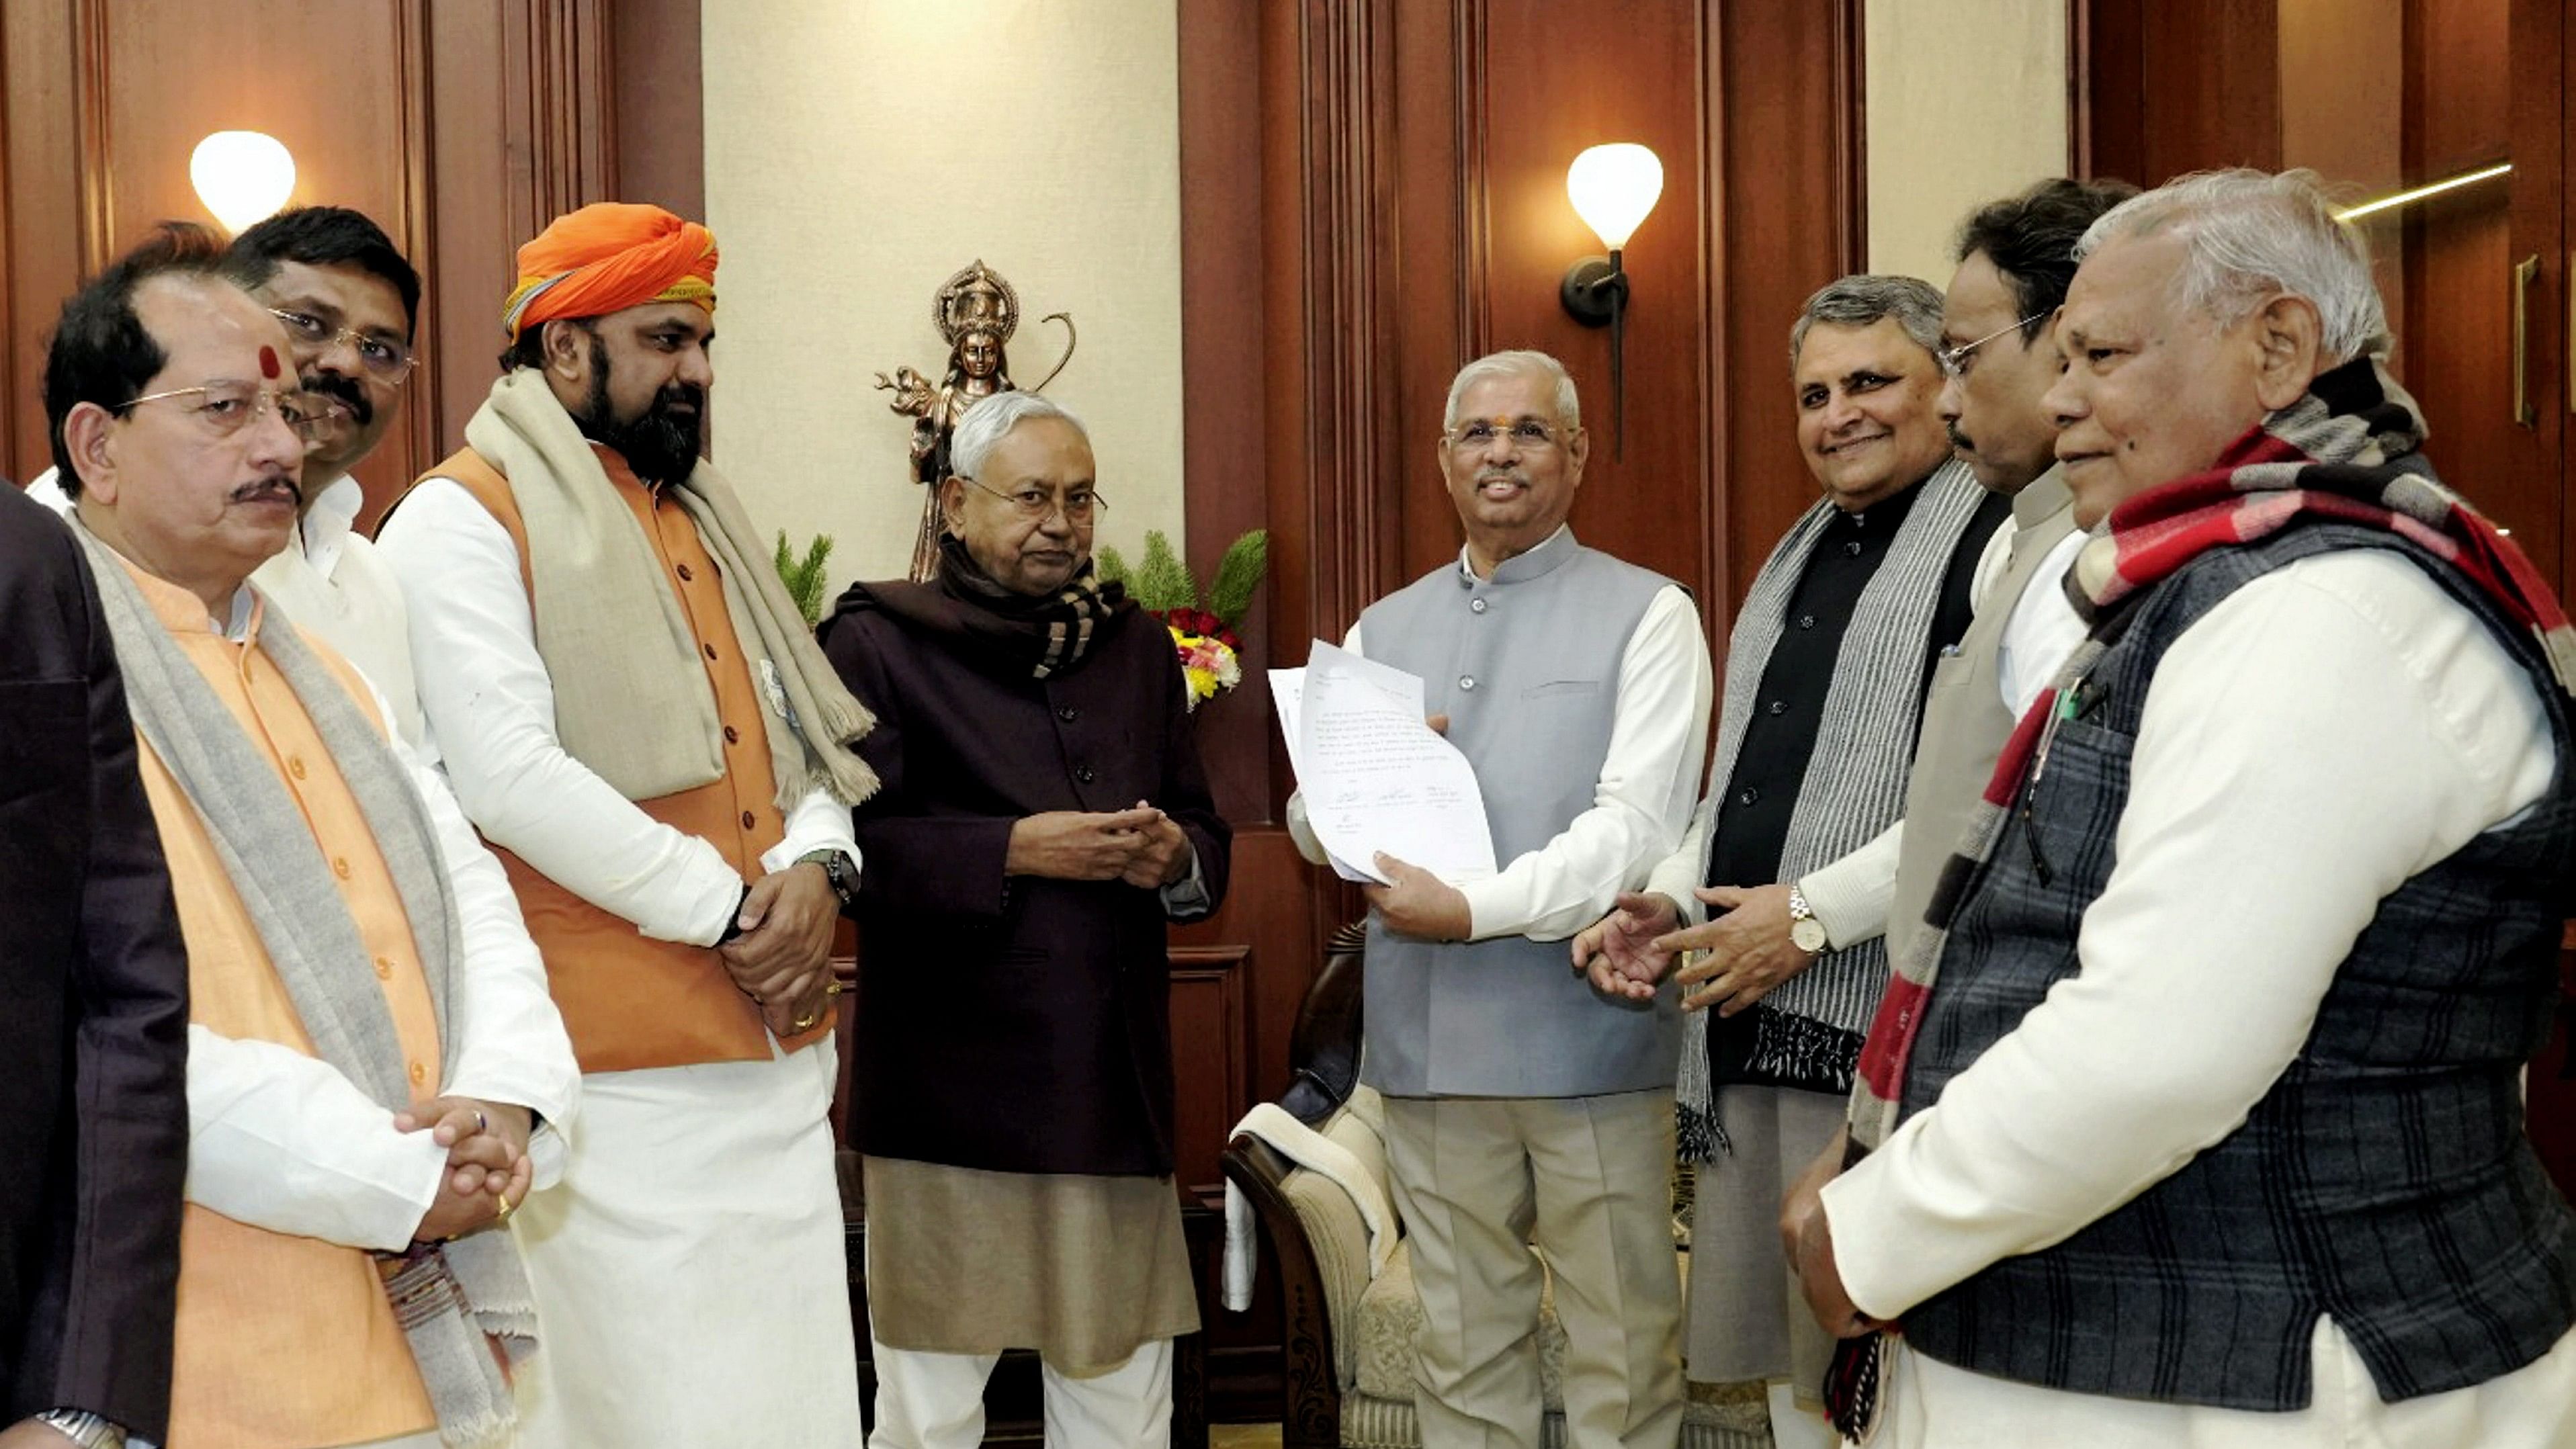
[1823,551,2576,1449]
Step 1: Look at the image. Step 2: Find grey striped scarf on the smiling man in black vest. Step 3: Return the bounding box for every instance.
[1674,458,1986,1161]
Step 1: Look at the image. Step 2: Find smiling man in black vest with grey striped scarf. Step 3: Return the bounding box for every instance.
[1574,275,2010,1444]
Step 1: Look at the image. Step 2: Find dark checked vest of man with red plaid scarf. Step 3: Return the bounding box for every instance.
[1903,523,2576,1411]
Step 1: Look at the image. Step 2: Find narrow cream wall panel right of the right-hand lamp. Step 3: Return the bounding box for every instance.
[1862,0,2066,286]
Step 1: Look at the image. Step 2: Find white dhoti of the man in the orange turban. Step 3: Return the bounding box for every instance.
[515,1037,861,1449]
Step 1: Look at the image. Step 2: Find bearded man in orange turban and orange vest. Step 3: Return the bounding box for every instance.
[379,204,876,1449]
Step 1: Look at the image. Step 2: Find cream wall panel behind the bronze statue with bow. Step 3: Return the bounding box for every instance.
[703,0,1183,589]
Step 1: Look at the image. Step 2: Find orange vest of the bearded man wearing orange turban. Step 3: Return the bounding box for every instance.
[423,445,830,1071]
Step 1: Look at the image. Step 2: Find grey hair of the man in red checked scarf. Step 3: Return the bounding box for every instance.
[2076,167,2388,363]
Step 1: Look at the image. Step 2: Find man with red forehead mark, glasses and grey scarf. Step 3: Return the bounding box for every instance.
[44,229,580,1449]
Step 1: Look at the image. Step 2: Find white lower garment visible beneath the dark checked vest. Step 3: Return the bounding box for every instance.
[1873,1318,2576,1449]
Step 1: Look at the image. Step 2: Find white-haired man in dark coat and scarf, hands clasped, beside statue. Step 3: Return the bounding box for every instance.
[822,391,1232,1449]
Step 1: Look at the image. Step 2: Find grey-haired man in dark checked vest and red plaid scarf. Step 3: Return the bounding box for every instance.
[1783,173,2576,1449]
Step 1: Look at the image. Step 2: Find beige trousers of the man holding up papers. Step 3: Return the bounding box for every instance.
[1386,1089,1682,1449]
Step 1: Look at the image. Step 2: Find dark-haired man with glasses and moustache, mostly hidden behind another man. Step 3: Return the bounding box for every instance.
[28,206,425,746]
